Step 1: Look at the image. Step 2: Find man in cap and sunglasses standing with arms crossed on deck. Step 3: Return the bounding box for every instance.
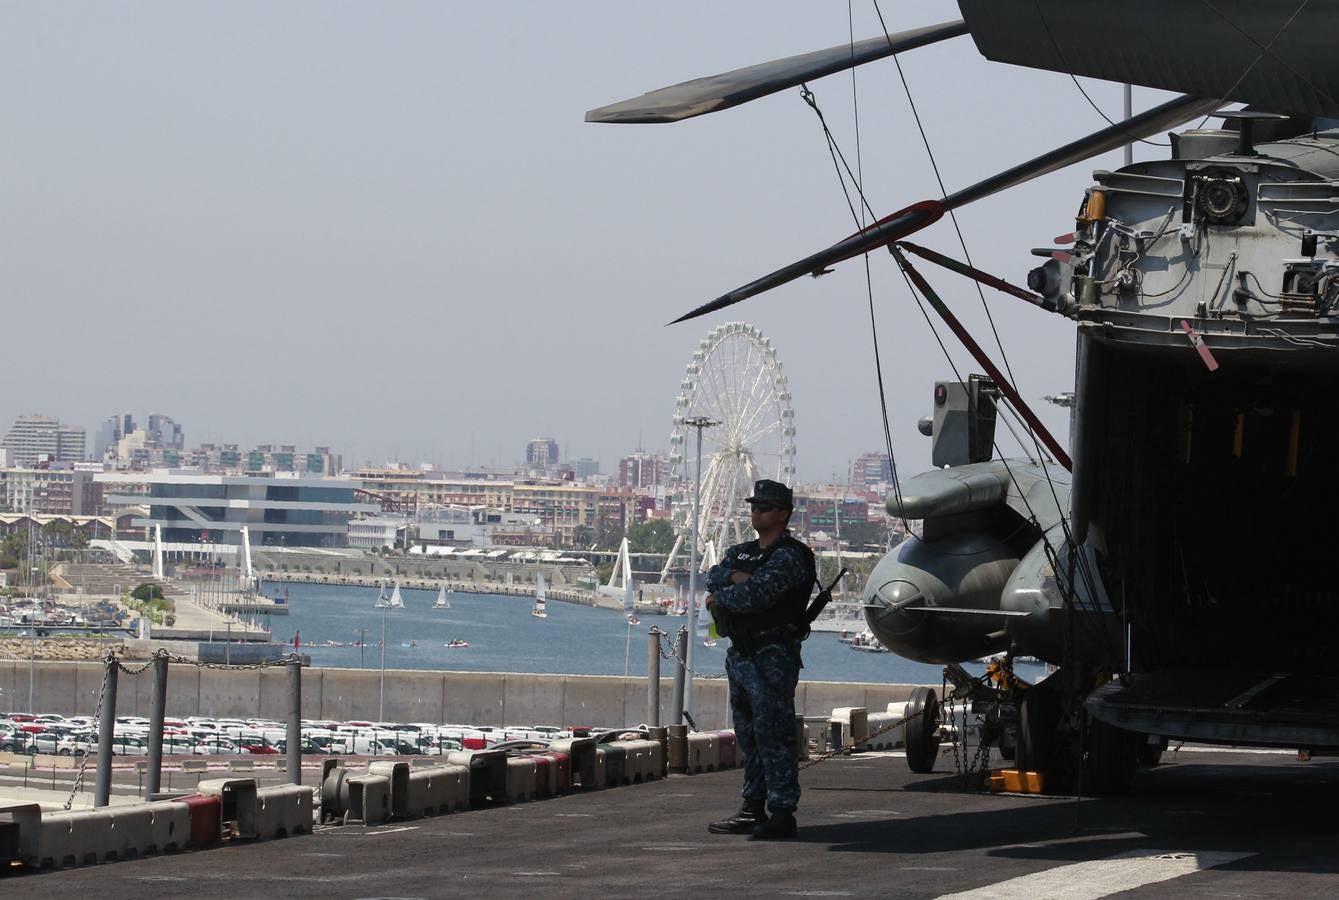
[707,479,814,840]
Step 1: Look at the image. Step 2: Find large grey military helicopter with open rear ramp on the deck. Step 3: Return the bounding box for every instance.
[586,0,1339,793]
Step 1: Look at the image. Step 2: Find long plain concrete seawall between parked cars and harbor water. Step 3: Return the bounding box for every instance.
[0,660,913,729]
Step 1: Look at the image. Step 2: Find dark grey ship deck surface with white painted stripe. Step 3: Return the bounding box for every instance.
[3,750,1339,900]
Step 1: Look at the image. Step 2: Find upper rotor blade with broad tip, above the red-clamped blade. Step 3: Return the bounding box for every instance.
[585,20,967,123]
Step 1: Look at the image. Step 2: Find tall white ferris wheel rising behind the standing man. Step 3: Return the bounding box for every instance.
[664,321,795,576]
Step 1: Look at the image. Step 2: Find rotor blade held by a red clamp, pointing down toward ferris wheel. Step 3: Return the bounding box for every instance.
[670,90,1220,325]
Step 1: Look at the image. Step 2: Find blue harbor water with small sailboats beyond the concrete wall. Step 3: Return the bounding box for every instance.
[253,583,1044,684]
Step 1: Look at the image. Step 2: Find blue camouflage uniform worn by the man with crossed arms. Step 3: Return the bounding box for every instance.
[706,530,814,813]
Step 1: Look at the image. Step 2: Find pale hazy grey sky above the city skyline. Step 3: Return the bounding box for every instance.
[0,0,1165,481]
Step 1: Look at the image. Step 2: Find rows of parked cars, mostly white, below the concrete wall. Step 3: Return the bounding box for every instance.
[0,713,572,757]
